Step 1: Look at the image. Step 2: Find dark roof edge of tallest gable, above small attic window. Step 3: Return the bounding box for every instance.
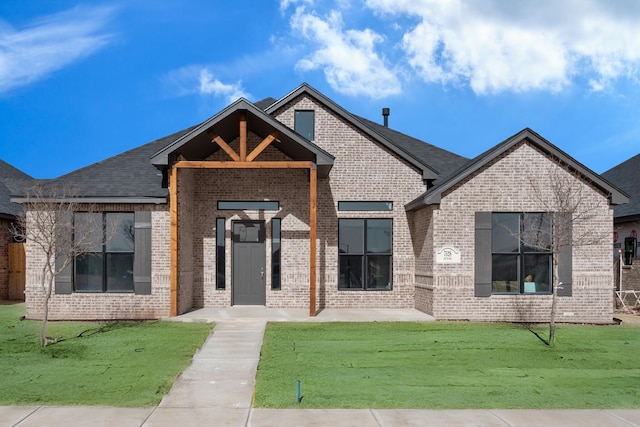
[265,83,438,180]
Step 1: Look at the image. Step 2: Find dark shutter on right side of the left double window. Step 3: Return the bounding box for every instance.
[133,211,151,295]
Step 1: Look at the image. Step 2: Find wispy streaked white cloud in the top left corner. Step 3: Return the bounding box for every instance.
[0,7,113,93]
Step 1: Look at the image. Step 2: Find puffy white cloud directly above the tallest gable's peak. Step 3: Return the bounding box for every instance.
[291,7,401,98]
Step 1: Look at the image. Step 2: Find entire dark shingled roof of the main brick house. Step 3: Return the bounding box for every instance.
[17,83,620,213]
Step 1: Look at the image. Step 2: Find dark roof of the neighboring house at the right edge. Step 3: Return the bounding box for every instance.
[602,154,640,222]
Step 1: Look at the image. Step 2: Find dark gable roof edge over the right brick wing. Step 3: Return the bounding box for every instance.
[405,128,629,211]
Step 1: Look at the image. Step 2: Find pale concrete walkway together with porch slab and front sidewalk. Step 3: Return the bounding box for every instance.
[0,307,640,427]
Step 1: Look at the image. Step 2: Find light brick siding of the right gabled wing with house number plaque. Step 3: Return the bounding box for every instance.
[419,143,613,323]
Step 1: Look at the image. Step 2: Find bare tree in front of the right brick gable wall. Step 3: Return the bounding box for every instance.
[520,160,610,346]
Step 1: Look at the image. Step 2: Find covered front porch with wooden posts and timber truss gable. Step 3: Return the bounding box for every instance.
[152,99,333,316]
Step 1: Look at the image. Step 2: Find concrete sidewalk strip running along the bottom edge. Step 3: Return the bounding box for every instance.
[7,406,640,427]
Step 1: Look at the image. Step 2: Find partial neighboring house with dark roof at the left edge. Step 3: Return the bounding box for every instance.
[0,160,33,300]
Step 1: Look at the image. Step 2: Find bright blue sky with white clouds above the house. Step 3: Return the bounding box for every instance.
[0,0,640,178]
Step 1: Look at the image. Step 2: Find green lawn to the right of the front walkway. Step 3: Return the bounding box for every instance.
[254,322,640,409]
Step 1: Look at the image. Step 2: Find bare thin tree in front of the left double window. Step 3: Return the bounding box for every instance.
[11,182,112,346]
